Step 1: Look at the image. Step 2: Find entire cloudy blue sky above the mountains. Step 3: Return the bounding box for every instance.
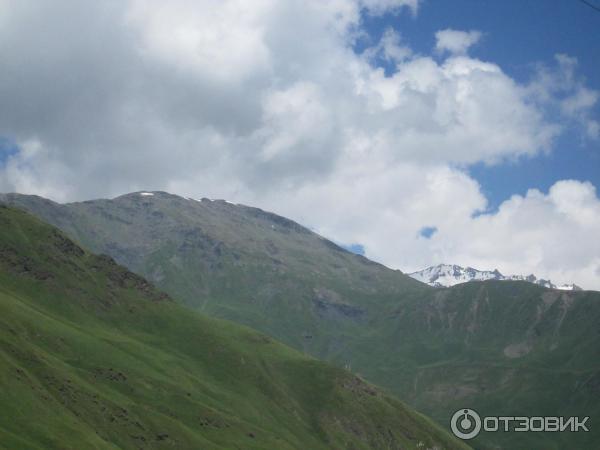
[0,0,600,289]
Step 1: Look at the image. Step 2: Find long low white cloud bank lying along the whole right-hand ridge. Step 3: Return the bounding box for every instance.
[253,175,600,289]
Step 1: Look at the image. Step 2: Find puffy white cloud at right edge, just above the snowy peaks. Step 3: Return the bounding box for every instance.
[429,180,600,289]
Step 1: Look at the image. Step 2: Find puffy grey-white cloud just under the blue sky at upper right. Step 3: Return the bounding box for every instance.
[356,57,557,164]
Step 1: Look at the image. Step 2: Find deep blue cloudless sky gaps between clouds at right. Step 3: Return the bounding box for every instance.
[358,0,600,211]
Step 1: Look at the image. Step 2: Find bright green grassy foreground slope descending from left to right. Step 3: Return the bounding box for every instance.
[0,206,468,450]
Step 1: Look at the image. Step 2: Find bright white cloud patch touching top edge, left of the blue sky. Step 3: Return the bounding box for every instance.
[127,0,274,83]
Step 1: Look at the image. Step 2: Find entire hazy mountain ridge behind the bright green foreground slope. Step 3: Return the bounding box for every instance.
[0,192,600,450]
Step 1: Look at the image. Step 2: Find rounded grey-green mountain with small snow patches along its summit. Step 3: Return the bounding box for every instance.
[0,192,433,359]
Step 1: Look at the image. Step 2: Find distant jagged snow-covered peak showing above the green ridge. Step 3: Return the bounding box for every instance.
[408,264,581,291]
